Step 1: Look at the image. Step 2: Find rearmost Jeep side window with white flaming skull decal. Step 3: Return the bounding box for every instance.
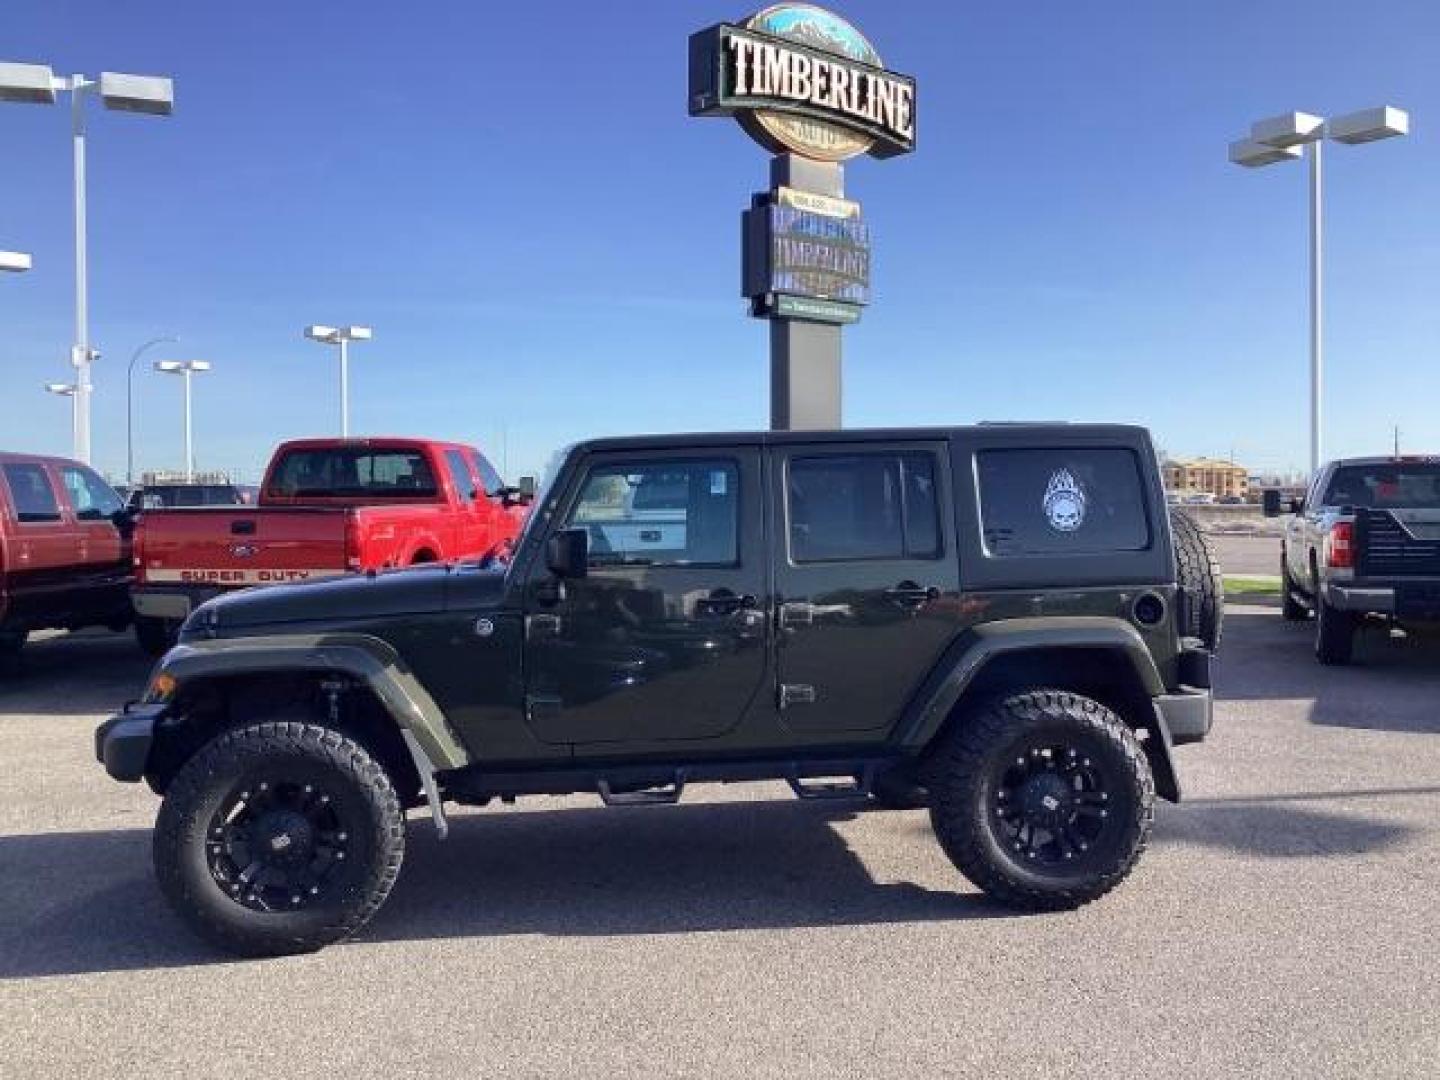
[975,448,1151,557]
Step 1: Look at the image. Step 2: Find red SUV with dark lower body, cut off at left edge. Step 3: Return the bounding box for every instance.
[0,454,131,668]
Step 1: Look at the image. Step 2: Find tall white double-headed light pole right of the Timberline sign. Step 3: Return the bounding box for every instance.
[1230,105,1410,475]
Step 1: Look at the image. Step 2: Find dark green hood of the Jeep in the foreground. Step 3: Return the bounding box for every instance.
[187,566,504,632]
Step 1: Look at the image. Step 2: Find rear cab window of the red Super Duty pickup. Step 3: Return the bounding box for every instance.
[265,446,439,500]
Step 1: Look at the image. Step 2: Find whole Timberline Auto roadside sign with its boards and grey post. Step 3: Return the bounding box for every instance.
[687,3,916,431]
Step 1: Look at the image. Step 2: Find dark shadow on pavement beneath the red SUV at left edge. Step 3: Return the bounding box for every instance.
[0,631,151,716]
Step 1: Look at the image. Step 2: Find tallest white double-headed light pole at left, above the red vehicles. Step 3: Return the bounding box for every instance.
[0,63,174,465]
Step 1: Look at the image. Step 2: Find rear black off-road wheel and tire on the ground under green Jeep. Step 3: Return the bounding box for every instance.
[926,690,1155,912]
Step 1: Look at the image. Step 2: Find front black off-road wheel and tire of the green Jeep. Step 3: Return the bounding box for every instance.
[154,721,405,956]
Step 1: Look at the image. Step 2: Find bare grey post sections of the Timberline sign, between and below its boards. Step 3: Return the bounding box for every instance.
[770,154,845,431]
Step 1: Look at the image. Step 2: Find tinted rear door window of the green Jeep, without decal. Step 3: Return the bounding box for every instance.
[786,454,940,563]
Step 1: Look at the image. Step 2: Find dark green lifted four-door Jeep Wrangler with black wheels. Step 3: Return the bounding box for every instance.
[96,423,1221,955]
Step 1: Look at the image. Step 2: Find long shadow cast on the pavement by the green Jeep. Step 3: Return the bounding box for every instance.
[0,789,1436,979]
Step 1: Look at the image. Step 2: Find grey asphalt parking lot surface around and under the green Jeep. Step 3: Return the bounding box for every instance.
[0,606,1440,1079]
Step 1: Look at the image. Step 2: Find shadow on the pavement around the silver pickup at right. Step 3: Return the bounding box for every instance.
[1214,605,1440,734]
